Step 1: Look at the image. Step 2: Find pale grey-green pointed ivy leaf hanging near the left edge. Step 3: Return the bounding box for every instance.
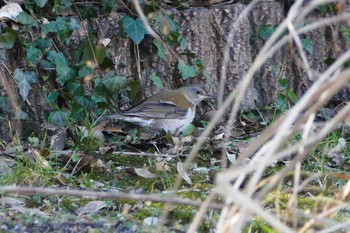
[13,68,37,100]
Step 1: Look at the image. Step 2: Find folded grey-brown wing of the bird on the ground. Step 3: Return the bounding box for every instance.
[123,101,187,119]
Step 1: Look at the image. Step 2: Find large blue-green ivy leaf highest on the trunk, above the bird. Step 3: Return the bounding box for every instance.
[121,16,148,44]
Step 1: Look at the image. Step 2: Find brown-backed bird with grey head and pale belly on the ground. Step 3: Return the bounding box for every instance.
[108,85,216,135]
